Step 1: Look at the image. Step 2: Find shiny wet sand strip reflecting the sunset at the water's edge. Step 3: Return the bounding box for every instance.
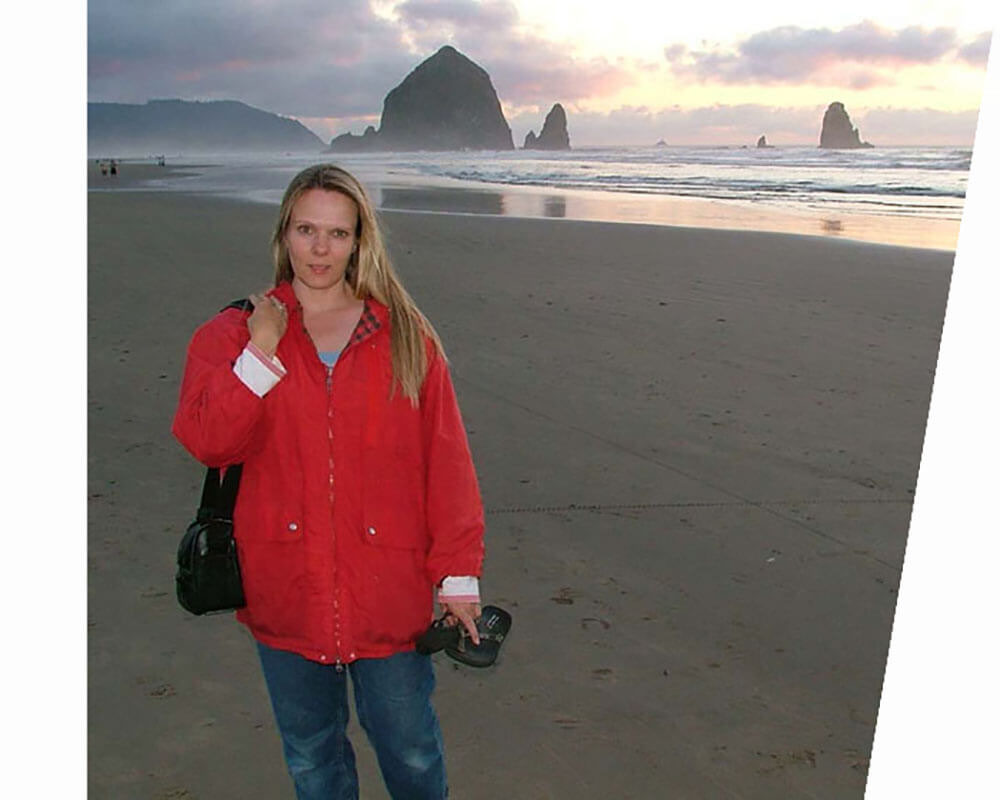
[88,161,960,253]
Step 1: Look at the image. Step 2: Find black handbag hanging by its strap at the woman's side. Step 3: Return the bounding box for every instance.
[177,464,246,615]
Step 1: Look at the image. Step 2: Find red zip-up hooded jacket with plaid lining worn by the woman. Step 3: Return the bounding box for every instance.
[173,283,484,663]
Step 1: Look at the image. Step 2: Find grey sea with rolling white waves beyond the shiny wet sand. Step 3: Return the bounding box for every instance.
[117,147,972,218]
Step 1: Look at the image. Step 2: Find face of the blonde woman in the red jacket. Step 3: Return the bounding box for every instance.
[285,189,358,290]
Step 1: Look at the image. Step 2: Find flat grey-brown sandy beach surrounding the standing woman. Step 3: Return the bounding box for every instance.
[88,184,953,800]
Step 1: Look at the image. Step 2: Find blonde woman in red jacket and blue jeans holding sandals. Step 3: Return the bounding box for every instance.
[173,164,483,800]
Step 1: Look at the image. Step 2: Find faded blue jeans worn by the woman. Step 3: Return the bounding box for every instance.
[257,642,448,800]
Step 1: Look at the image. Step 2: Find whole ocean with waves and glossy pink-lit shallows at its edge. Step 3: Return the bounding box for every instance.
[95,146,972,249]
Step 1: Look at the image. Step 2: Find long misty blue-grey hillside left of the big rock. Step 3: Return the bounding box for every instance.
[87,100,325,157]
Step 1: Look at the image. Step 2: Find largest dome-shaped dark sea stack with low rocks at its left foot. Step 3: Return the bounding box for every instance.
[330,45,514,152]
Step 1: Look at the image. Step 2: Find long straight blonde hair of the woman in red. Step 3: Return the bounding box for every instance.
[271,164,445,406]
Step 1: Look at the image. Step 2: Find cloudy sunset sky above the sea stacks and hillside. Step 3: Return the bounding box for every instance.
[88,0,992,145]
